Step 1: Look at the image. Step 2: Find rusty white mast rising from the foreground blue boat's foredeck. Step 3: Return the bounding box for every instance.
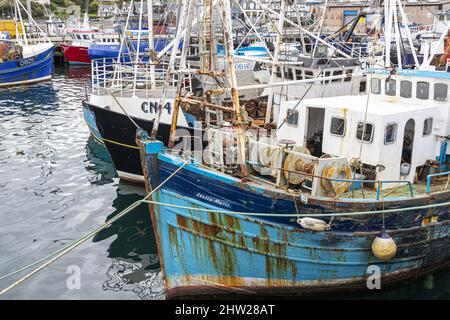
[219,0,250,181]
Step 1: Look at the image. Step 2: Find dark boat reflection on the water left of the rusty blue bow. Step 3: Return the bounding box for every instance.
[86,136,164,299]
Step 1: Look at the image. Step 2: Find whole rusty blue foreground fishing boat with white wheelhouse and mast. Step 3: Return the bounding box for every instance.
[137,1,450,298]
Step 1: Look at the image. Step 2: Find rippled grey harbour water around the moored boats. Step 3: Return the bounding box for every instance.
[0,67,450,299]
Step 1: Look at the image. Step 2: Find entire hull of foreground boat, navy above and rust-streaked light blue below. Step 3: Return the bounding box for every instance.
[143,142,450,297]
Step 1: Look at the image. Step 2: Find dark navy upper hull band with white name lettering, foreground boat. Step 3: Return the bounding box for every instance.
[144,149,450,232]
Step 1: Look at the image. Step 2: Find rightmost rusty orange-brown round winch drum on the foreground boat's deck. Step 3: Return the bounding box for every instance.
[321,164,352,195]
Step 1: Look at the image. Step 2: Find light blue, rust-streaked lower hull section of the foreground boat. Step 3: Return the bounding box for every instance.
[155,189,449,298]
